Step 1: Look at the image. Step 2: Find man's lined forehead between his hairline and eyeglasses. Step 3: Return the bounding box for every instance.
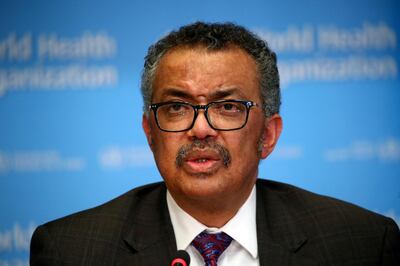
[152,47,260,102]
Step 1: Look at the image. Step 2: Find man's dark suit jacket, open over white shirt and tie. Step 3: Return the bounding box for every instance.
[30,180,400,266]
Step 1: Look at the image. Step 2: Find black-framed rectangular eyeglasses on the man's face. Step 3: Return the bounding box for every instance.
[149,100,259,132]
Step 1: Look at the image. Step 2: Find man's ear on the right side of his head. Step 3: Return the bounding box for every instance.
[261,114,282,159]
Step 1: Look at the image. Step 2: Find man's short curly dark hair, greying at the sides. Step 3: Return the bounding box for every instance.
[141,22,281,117]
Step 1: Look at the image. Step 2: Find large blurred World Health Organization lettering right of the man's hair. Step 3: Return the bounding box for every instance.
[255,22,398,88]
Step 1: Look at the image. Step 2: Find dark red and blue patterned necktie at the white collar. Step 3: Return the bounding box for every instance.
[192,231,232,266]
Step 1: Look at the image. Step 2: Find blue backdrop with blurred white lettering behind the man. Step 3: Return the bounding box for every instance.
[0,0,400,266]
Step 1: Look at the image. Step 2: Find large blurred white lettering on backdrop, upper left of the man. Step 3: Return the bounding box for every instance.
[0,32,118,96]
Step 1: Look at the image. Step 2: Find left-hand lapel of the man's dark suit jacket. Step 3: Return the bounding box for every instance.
[122,184,176,265]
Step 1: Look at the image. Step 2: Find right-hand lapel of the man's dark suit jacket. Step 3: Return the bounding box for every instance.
[256,180,315,266]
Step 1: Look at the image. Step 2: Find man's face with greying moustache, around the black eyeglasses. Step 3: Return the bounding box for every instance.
[143,47,280,207]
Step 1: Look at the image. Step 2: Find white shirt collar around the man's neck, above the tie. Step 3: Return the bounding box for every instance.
[167,186,258,258]
